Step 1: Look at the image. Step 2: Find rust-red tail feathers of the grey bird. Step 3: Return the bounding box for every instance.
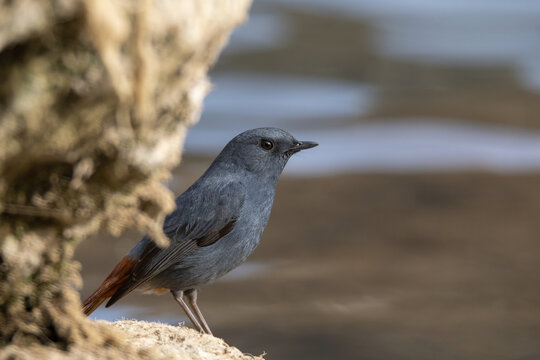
[83,256,137,316]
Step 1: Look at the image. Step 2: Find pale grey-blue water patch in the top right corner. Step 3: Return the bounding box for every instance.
[274,0,540,91]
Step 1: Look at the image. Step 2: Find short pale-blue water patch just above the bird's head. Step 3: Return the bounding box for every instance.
[197,73,376,124]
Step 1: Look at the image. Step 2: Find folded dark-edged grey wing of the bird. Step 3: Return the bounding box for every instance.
[107,182,245,306]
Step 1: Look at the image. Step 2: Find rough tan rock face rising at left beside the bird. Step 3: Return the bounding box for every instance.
[0,0,250,358]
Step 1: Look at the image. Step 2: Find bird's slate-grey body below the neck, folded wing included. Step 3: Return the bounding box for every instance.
[108,168,275,305]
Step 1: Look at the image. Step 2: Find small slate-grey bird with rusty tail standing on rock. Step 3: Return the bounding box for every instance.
[83,128,318,334]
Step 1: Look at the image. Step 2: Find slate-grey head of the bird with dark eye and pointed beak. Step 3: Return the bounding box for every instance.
[215,128,318,178]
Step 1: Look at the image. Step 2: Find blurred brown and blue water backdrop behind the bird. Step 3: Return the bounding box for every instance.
[77,0,540,360]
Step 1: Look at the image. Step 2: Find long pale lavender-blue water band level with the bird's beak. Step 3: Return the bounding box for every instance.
[186,115,540,176]
